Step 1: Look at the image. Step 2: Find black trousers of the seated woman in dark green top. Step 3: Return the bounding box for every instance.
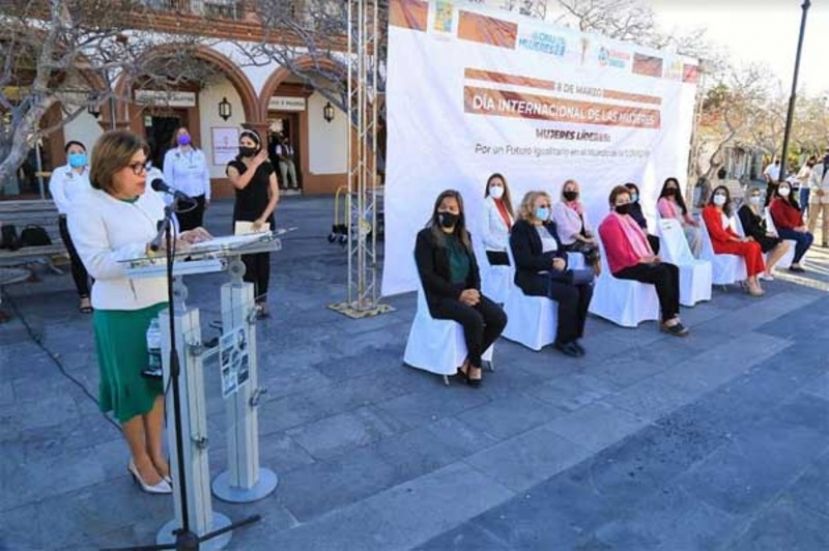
[431,295,507,367]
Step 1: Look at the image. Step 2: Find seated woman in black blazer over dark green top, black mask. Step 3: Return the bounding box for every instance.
[415,190,507,386]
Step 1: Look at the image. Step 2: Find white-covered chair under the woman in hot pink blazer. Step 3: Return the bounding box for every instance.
[588,239,659,327]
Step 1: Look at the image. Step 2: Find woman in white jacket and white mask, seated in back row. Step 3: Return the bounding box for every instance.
[481,173,515,266]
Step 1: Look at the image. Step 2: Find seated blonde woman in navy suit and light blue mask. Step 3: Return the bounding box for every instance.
[510,191,593,357]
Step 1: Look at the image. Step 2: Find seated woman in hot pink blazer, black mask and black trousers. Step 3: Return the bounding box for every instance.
[599,186,688,337]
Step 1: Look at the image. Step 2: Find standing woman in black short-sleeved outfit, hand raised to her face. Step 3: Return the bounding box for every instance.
[227,130,279,317]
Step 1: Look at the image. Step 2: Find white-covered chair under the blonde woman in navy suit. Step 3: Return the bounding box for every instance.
[503,247,558,351]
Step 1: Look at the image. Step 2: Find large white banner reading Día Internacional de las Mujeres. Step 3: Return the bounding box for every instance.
[383,0,698,295]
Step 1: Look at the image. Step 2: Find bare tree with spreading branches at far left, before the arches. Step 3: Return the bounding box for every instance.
[0,0,218,194]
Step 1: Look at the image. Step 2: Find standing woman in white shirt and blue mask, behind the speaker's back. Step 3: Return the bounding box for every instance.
[49,140,92,314]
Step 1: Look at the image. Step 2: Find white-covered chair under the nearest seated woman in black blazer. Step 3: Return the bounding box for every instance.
[403,278,495,385]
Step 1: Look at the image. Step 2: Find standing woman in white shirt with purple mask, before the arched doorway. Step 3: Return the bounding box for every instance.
[163,127,210,231]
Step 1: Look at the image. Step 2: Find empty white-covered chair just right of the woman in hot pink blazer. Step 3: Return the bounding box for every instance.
[657,218,713,306]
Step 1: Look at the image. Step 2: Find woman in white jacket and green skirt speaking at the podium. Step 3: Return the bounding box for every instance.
[68,131,209,494]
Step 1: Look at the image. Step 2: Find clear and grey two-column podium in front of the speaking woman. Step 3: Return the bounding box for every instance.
[125,232,282,550]
